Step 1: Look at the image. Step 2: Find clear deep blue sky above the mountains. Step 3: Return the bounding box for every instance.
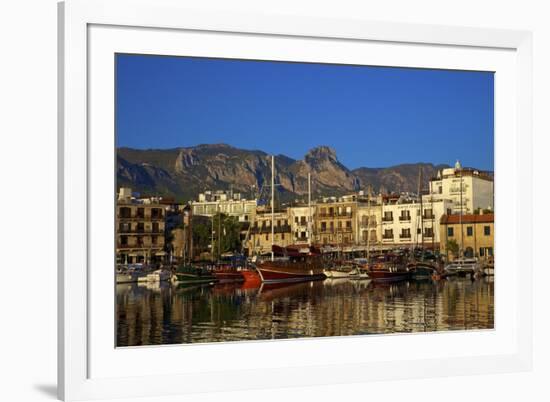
[116,55,494,170]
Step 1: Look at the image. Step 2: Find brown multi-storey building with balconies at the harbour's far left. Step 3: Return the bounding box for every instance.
[116,188,166,264]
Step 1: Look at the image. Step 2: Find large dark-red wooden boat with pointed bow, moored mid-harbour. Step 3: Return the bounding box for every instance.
[256,245,326,283]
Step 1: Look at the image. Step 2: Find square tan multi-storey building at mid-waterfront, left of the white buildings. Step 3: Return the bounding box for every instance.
[314,195,357,245]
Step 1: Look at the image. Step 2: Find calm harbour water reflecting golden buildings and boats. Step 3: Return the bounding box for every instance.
[116,277,494,346]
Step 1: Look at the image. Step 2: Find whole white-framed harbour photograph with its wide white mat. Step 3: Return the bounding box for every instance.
[59,0,532,400]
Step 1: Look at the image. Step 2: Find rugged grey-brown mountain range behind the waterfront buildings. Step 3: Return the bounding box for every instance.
[117,144,448,201]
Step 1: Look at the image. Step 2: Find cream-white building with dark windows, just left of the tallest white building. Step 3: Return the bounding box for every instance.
[380,195,453,249]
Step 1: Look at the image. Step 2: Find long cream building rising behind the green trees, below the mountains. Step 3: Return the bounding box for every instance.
[191,191,256,222]
